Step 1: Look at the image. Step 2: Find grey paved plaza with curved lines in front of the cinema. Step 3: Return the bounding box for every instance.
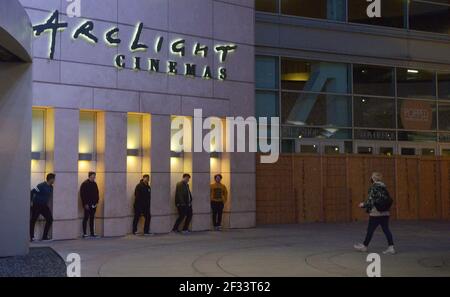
[34,222,450,277]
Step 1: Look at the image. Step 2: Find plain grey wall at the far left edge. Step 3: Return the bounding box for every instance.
[0,1,32,257]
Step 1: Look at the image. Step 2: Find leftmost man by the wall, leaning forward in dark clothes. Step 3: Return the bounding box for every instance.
[30,173,56,242]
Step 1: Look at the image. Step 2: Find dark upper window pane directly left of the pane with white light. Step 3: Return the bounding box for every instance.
[353,65,395,96]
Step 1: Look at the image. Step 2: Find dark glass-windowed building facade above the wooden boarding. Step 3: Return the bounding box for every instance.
[256,0,450,156]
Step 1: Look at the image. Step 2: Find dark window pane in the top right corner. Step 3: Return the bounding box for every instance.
[409,1,450,34]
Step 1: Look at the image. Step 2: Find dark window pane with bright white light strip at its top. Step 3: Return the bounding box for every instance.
[397,68,436,99]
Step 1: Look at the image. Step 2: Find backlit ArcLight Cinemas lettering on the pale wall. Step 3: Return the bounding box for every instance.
[33,10,237,80]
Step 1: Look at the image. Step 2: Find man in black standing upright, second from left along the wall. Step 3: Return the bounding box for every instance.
[80,172,100,238]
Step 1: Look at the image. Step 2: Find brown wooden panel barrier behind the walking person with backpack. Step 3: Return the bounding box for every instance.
[256,154,450,224]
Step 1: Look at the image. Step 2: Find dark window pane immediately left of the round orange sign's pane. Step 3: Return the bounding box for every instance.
[353,97,395,129]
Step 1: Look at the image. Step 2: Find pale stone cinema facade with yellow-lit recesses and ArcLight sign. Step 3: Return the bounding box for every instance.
[21,0,255,239]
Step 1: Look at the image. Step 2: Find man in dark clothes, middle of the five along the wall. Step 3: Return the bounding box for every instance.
[133,174,152,236]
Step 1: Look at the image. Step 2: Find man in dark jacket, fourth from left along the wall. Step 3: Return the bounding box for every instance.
[172,173,192,234]
